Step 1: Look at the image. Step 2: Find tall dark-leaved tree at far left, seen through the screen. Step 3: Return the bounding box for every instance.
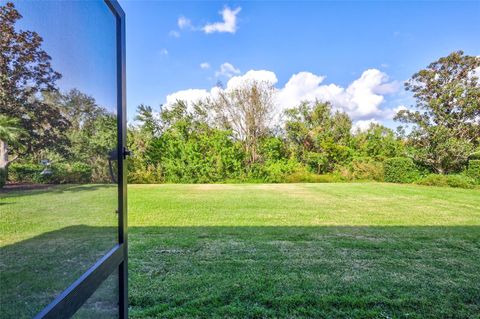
[0,2,69,162]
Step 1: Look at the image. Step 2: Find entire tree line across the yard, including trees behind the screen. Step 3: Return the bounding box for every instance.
[0,3,480,185]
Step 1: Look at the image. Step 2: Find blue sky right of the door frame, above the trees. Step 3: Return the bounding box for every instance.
[120,0,480,130]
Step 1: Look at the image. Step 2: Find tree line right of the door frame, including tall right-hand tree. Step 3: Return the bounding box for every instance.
[124,51,480,183]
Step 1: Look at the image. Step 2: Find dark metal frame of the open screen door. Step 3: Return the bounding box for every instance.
[34,0,128,319]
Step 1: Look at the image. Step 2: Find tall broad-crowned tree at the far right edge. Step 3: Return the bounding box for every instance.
[395,51,480,173]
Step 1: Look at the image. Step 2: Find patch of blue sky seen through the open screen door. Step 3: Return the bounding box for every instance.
[9,0,116,111]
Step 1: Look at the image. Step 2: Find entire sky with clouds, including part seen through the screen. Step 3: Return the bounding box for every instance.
[10,0,480,127]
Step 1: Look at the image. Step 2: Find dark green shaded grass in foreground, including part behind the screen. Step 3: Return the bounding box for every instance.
[0,225,480,318]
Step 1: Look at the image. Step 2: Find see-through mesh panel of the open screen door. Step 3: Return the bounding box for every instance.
[0,1,119,318]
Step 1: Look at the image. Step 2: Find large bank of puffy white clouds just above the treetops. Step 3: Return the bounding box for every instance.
[161,68,405,124]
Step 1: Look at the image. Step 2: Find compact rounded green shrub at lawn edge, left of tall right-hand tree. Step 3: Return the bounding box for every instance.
[383,157,420,183]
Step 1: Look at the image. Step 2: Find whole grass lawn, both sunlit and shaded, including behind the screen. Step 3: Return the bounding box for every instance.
[0,183,480,318]
